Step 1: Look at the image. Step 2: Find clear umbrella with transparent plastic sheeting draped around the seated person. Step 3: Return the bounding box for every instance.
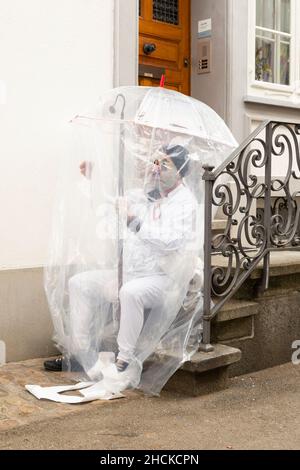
[45,87,237,394]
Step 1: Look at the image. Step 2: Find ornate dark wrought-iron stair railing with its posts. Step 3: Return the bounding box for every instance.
[201,121,300,351]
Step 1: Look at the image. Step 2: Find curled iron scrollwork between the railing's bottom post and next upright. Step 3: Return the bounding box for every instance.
[211,137,267,297]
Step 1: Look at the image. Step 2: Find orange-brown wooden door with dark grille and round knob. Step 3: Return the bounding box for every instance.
[139,0,190,95]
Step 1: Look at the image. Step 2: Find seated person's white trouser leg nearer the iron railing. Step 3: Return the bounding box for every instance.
[117,275,169,362]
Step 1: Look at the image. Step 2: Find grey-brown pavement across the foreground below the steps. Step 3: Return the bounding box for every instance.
[0,359,300,450]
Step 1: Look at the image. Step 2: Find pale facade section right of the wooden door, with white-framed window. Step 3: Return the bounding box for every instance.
[191,0,300,142]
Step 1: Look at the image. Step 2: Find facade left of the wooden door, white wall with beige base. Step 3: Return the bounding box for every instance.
[0,0,137,361]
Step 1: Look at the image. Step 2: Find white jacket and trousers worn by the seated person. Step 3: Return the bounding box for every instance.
[69,181,197,370]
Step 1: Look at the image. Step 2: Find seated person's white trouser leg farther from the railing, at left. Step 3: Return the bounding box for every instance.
[69,270,117,354]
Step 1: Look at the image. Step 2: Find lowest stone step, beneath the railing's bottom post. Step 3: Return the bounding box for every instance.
[164,344,241,396]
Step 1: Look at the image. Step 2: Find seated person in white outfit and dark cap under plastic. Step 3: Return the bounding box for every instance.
[44,145,197,380]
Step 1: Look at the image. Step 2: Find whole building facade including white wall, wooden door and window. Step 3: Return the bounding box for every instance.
[0,0,300,361]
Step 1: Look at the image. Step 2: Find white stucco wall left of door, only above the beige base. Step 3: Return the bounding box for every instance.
[0,0,114,269]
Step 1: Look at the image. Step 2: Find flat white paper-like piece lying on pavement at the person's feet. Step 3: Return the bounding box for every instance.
[25,380,124,404]
